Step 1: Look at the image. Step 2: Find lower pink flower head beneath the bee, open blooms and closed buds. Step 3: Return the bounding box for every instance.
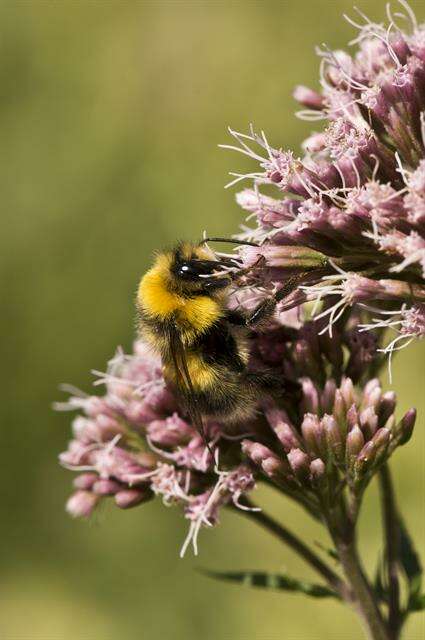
[57,314,415,553]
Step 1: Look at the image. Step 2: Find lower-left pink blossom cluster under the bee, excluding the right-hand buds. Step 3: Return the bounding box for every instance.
[56,342,255,551]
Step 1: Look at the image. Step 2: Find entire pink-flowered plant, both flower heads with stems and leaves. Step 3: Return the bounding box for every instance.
[57,0,425,640]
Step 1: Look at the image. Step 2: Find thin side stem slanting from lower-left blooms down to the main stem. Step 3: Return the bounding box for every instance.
[232,497,351,601]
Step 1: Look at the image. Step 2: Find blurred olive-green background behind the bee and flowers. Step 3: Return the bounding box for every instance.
[0,0,425,640]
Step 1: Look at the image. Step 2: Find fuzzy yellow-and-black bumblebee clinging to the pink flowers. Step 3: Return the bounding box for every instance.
[137,238,296,437]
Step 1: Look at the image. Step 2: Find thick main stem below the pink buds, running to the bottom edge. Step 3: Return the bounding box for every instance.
[335,538,391,640]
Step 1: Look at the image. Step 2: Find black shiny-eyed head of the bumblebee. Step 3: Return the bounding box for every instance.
[170,243,231,295]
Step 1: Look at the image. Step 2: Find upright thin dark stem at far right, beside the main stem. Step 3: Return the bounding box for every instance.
[379,465,401,640]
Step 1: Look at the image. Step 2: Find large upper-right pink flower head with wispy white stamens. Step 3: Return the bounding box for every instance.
[222,1,425,352]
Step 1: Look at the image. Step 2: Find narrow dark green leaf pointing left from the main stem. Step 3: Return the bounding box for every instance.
[200,569,339,598]
